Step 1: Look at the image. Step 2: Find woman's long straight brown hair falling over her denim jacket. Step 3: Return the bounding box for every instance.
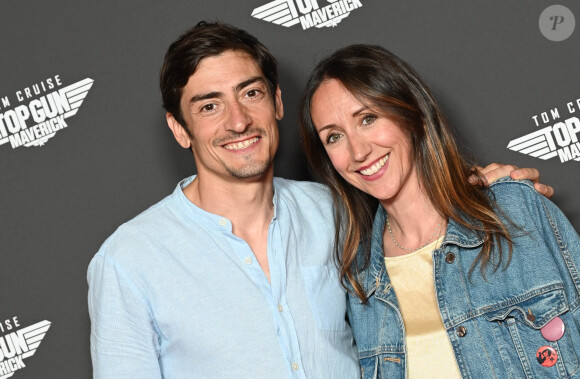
[299,45,512,301]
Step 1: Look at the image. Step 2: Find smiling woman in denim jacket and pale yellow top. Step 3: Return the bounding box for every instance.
[300,45,580,378]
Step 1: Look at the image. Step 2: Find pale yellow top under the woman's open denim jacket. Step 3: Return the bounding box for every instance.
[385,237,461,379]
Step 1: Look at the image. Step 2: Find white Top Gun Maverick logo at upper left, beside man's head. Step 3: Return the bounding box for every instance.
[0,75,93,149]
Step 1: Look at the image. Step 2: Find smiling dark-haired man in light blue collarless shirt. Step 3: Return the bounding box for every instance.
[88,22,552,378]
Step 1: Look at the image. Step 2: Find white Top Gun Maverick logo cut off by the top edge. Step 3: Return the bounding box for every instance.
[252,0,362,30]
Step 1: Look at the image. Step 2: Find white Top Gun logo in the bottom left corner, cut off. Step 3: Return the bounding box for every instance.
[0,317,50,379]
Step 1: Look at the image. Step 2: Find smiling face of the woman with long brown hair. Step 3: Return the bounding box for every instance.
[311,79,417,205]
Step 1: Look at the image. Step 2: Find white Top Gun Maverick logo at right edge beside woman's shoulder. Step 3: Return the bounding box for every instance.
[507,99,580,163]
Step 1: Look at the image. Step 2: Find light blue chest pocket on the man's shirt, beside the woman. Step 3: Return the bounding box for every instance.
[300,265,347,331]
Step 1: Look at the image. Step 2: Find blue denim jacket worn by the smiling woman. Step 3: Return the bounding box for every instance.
[348,178,580,378]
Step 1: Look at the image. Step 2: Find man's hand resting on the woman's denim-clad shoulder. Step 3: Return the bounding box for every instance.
[469,163,554,199]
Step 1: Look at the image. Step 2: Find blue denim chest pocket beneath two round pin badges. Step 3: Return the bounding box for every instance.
[485,284,579,378]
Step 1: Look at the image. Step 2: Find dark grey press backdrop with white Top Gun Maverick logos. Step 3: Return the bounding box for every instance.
[0,0,580,378]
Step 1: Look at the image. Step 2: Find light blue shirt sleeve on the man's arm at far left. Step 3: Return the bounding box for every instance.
[87,252,162,379]
